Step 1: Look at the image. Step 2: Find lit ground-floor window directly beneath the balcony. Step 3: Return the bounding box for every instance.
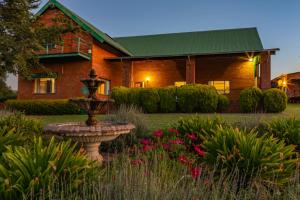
[34,78,55,94]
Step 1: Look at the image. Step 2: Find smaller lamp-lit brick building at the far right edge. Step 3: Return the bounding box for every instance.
[272,72,300,103]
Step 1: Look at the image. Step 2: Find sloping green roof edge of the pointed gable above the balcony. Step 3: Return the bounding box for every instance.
[36,0,132,55]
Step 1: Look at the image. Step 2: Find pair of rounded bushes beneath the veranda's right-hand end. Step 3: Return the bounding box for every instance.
[240,87,288,113]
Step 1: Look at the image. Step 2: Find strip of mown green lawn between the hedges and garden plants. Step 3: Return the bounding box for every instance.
[32,104,300,130]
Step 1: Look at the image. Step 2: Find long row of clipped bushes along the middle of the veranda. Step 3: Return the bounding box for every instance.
[111,84,229,113]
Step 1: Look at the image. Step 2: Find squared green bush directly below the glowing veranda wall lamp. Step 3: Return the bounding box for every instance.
[140,88,159,113]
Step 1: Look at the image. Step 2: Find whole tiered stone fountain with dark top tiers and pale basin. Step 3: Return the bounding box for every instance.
[44,69,135,162]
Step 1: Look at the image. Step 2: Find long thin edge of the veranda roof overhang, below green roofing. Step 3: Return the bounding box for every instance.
[105,48,280,62]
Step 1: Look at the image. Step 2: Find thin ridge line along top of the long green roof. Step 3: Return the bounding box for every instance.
[113,27,257,39]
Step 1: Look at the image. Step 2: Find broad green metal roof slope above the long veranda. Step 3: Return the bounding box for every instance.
[114,28,263,57]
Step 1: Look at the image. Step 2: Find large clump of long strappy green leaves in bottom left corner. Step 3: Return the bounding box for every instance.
[0,138,93,199]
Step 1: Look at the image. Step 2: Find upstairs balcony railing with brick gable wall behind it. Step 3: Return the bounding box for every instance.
[37,38,92,56]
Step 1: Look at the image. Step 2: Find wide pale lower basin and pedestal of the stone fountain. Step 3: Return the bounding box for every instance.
[44,122,135,163]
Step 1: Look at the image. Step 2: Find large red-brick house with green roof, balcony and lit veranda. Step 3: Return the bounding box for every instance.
[18,0,279,110]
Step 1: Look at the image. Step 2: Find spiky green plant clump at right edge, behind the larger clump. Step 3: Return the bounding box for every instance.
[260,118,300,152]
